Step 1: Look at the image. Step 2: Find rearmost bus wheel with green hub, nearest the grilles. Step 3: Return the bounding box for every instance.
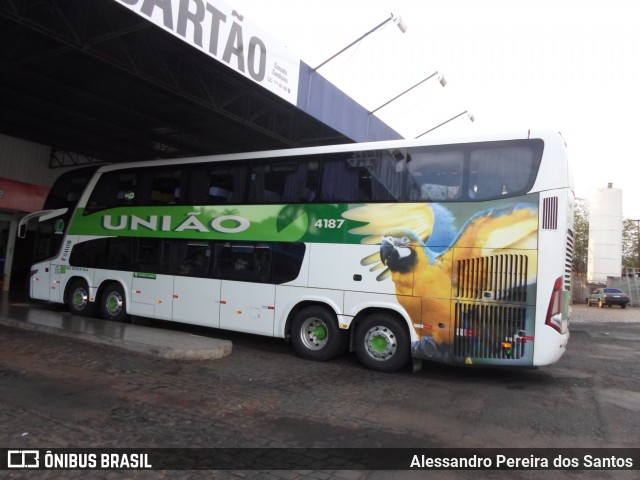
[355,313,410,373]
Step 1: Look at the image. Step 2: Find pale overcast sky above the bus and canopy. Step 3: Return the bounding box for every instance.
[226,0,640,219]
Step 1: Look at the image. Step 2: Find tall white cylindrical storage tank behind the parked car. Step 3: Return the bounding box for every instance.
[587,183,622,283]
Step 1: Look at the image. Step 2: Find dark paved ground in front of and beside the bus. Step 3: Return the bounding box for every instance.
[0,300,640,480]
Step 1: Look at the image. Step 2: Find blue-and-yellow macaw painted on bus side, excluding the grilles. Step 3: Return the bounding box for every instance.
[343,203,538,359]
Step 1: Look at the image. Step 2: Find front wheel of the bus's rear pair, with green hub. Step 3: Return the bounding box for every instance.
[291,306,348,362]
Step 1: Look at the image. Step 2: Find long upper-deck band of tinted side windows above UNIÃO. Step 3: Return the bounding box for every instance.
[79,140,544,209]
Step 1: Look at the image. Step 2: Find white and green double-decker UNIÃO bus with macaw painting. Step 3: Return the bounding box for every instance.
[20,132,574,371]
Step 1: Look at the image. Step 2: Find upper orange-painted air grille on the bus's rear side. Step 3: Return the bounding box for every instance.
[457,254,529,303]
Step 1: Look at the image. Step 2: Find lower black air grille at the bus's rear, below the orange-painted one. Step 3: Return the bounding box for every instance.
[453,303,527,360]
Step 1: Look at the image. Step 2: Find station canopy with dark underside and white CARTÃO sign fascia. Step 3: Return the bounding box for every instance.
[0,0,399,168]
